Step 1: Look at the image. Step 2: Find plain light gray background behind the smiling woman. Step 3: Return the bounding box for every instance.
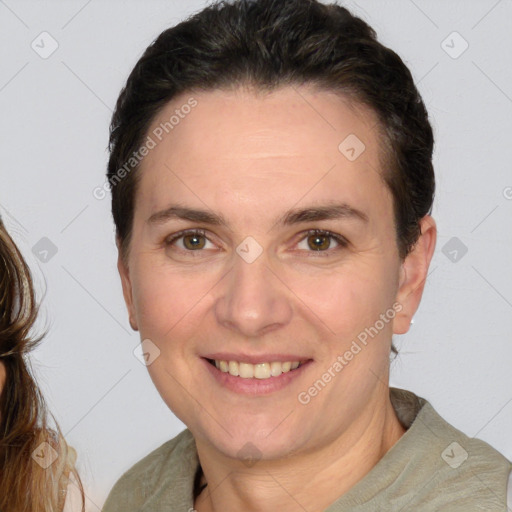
[0,0,512,511]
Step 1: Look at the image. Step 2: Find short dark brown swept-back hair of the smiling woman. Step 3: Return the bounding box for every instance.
[107,0,435,264]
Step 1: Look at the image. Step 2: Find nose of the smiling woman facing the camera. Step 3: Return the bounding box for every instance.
[215,250,292,338]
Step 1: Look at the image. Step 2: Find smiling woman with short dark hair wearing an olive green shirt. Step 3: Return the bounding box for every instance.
[104,0,511,512]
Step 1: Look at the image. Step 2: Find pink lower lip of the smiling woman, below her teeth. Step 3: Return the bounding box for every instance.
[203,358,312,395]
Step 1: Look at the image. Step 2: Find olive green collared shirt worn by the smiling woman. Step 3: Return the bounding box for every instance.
[103,387,512,512]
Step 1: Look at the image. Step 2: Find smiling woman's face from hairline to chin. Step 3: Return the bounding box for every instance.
[119,87,430,459]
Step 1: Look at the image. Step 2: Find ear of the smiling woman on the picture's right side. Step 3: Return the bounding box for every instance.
[393,215,437,334]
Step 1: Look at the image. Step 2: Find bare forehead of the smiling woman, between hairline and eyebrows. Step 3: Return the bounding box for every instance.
[136,86,391,227]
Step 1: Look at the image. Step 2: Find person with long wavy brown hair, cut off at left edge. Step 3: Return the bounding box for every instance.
[0,219,84,512]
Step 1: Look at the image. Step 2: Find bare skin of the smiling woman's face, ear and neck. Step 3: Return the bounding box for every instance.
[118,86,436,512]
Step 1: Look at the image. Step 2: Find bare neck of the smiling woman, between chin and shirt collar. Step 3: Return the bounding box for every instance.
[194,388,405,512]
